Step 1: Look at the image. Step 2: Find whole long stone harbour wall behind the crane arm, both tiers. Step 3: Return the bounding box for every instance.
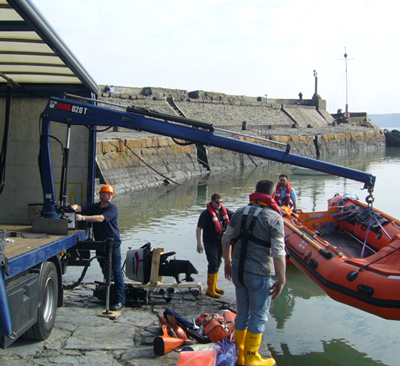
[96,86,385,192]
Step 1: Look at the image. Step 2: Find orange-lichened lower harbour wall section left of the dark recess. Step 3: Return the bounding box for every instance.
[96,136,208,192]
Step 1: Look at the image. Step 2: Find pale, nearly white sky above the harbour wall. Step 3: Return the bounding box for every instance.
[33,0,400,114]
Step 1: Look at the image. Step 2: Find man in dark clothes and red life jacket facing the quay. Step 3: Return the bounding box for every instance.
[196,193,233,298]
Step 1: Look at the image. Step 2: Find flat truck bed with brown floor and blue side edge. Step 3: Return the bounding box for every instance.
[0,225,86,279]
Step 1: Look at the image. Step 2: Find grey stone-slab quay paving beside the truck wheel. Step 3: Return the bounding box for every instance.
[0,283,270,366]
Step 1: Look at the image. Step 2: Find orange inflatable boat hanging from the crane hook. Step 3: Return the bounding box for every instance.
[283,195,400,320]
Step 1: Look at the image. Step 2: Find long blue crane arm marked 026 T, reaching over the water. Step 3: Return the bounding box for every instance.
[42,98,375,190]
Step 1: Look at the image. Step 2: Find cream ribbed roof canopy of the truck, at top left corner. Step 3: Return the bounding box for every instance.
[0,0,99,96]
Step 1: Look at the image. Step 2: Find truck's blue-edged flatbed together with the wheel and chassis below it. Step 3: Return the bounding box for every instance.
[0,225,86,348]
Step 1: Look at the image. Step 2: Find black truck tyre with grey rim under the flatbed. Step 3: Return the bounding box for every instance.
[23,262,58,340]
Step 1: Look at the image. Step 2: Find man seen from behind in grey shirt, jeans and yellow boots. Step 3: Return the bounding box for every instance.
[222,179,286,366]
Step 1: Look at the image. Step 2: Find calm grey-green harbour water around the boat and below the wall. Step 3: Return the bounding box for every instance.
[65,149,400,366]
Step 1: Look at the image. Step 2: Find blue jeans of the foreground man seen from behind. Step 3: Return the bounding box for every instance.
[232,266,274,334]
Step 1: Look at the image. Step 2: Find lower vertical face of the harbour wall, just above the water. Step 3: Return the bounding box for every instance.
[96,129,385,193]
